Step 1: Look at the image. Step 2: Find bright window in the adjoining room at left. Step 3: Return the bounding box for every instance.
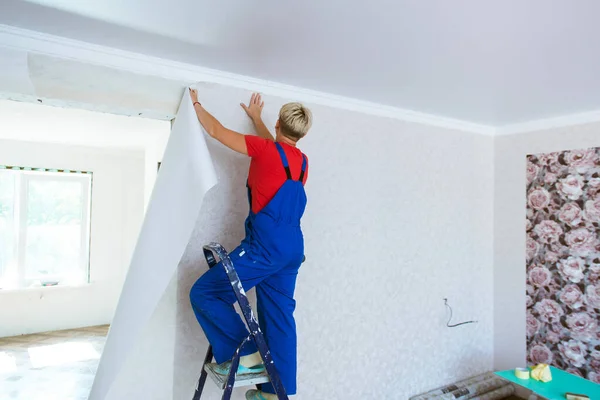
[0,166,92,289]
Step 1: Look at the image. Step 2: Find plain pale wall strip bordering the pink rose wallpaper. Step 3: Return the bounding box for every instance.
[494,123,600,369]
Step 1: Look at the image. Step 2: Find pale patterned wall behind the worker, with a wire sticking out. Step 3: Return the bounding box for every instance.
[108,85,493,400]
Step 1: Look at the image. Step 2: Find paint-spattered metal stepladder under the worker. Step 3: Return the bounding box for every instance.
[193,243,289,400]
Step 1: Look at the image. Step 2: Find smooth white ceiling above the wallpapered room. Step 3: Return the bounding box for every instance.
[0,0,600,126]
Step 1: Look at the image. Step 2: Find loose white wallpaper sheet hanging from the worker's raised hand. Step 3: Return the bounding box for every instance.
[89,89,217,400]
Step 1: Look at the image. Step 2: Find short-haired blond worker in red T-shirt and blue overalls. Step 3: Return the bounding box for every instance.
[190,89,312,400]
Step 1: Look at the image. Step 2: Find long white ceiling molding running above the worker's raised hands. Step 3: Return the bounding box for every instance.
[0,24,496,135]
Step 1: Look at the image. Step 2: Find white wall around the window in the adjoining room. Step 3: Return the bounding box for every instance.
[0,140,144,337]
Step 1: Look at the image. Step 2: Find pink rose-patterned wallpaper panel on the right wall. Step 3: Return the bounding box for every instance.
[525,148,600,383]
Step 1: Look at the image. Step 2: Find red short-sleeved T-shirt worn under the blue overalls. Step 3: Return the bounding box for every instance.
[246,135,308,213]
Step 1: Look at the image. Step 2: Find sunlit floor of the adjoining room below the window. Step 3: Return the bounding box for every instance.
[0,325,108,400]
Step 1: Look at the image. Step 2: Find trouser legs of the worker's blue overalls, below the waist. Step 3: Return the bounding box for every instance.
[190,244,302,395]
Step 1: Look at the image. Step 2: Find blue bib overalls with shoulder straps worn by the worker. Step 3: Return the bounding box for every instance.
[190,143,307,395]
